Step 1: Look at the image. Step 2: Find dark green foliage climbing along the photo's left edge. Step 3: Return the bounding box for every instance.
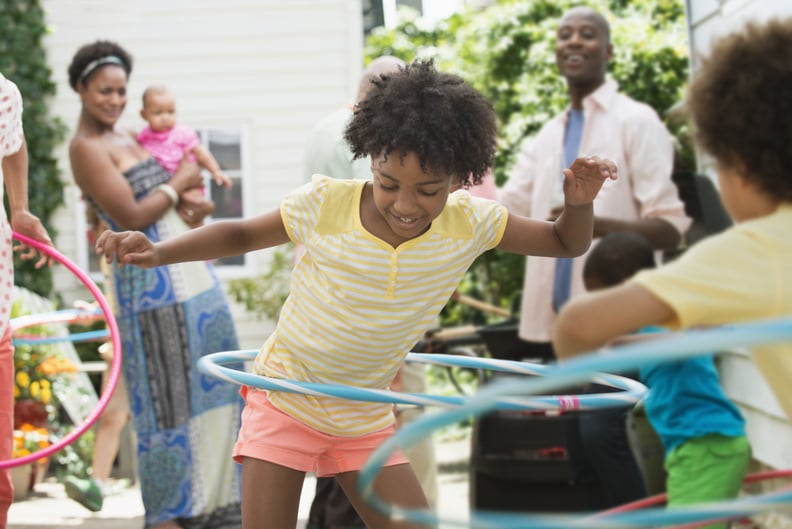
[0,0,66,296]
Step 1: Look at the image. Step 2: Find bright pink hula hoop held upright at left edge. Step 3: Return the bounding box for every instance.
[0,232,121,468]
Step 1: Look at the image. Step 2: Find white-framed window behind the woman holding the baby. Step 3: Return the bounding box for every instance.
[77,127,252,281]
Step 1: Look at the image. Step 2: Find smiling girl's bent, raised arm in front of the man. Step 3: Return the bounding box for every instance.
[498,156,617,257]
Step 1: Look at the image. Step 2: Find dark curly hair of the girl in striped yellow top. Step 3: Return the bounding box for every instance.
[344,60,497,187]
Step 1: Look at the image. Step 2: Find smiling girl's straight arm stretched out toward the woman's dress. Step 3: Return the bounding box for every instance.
[96,210,289,268]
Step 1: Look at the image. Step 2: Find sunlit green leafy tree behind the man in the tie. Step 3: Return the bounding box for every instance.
[365,0,693,324]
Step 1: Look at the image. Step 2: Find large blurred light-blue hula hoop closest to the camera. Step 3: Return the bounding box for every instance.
[358,318,792,529]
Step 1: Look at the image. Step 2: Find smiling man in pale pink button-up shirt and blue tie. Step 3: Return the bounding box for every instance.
[499,7,691,509]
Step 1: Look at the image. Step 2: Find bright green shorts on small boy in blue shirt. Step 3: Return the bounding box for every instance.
[665,435,751,529]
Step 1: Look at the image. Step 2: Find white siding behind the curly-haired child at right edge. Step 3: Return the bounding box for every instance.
[686,0,792,512]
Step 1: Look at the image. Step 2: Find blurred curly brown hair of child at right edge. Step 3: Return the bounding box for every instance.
[687,18,792,202]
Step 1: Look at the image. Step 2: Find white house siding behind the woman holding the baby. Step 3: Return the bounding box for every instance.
[43,0,363,348]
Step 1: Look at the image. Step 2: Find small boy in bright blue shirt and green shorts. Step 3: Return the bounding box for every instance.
[583,231,751,529]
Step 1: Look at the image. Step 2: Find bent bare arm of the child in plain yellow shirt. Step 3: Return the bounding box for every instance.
[553,281,675,358]
